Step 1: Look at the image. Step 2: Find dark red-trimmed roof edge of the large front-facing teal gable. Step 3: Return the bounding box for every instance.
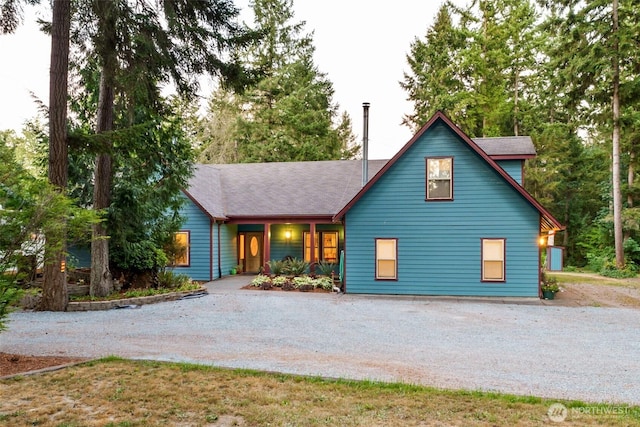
[334,111,564,231]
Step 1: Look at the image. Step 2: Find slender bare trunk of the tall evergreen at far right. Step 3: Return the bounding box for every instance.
[611,0,624,268]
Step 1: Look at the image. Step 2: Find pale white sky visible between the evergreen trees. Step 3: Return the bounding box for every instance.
[0,0,466,159]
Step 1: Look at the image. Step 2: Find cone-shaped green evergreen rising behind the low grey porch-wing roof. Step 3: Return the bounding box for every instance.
[226,0,355,162]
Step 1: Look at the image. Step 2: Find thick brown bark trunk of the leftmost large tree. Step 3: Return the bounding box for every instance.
[39,0,71,311]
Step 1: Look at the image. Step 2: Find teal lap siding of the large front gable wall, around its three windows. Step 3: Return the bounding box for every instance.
[345,124,540,297]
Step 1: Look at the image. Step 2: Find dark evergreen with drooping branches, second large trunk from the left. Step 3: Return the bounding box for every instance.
[65,0,252,295]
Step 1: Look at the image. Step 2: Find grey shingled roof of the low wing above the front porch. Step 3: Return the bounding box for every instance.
[184,160,386,221]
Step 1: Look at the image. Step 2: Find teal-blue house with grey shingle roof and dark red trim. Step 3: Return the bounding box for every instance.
[176,113,563,297]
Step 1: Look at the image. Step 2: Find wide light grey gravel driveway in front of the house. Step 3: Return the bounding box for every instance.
[0,278,640,404]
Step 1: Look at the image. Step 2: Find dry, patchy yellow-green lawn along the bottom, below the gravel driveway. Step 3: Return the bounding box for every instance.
[0,358,640,426]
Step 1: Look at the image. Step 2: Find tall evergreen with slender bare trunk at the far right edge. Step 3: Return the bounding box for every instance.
[542,0,640,268]
